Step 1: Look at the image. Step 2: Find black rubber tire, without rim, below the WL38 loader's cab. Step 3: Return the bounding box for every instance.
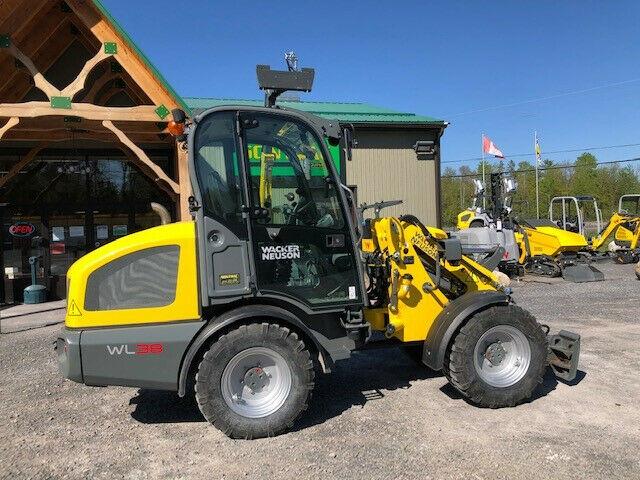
[195,323,314,439]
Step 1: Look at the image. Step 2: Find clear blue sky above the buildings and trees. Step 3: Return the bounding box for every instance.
[103,0,640,172]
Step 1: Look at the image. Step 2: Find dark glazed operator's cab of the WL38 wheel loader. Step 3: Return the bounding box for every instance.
[188,106,363,312]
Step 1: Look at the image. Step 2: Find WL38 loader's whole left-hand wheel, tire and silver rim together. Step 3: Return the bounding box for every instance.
[195,323,314,439]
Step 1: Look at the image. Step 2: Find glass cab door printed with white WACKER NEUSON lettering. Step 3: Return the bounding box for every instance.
[239,111,362,309]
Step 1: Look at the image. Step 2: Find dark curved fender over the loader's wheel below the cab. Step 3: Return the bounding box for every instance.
[178,305,332,397]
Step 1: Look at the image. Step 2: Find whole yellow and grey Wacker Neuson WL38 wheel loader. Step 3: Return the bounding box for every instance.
[56,62,580,438]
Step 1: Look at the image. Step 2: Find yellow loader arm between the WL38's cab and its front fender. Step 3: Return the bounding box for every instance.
[362,217,501,342]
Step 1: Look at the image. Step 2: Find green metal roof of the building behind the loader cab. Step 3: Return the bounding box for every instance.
[184,97,446,126]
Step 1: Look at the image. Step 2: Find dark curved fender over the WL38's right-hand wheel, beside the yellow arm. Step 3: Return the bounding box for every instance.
[422,291,511,370]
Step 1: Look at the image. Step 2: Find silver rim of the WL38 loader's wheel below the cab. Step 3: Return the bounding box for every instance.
[221,347,291,418]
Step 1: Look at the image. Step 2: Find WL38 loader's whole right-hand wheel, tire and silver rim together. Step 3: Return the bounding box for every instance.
[443,305,547,408]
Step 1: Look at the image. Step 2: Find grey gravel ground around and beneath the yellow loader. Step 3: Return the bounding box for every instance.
[0,264,640,479]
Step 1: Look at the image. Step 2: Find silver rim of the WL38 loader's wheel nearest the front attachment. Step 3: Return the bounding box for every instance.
[473,325,531,388]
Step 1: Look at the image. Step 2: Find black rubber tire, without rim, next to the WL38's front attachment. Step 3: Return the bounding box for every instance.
[443,305,547,408]
